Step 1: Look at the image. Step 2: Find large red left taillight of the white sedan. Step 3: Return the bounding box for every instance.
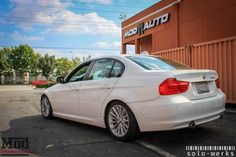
[159,78,189,95]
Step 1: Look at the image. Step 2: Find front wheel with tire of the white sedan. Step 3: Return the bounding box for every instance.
[40,95,53,119]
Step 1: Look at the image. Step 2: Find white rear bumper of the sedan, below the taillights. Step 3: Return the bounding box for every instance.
[129,90,225,131]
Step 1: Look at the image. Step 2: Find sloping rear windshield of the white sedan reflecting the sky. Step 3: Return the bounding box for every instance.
[126,55,190,70]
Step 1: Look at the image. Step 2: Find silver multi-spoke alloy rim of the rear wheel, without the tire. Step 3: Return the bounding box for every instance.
[108,104,129,137]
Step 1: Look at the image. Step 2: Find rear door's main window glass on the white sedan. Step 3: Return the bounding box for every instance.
[88,59,114,80]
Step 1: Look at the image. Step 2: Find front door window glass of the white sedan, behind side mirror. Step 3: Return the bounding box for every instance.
[68,63,90,82]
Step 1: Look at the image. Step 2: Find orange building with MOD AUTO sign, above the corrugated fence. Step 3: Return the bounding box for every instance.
[122,0,236,54]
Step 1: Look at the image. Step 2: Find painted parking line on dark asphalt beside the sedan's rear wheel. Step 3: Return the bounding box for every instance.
[136,140,176,157]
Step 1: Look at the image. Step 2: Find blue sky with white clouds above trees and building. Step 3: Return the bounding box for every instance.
[0,0,159,59]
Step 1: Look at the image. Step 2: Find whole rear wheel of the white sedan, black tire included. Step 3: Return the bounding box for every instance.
[105,101,140,141]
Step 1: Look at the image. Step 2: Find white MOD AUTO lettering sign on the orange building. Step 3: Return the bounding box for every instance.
[125,13,170,38]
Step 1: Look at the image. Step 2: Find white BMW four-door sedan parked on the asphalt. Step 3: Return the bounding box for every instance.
[41,55,225,141]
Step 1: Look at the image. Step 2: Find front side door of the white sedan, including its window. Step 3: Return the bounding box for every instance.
[51,62,91,116]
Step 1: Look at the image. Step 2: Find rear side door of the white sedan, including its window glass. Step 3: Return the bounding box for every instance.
[79,58,124,117]
